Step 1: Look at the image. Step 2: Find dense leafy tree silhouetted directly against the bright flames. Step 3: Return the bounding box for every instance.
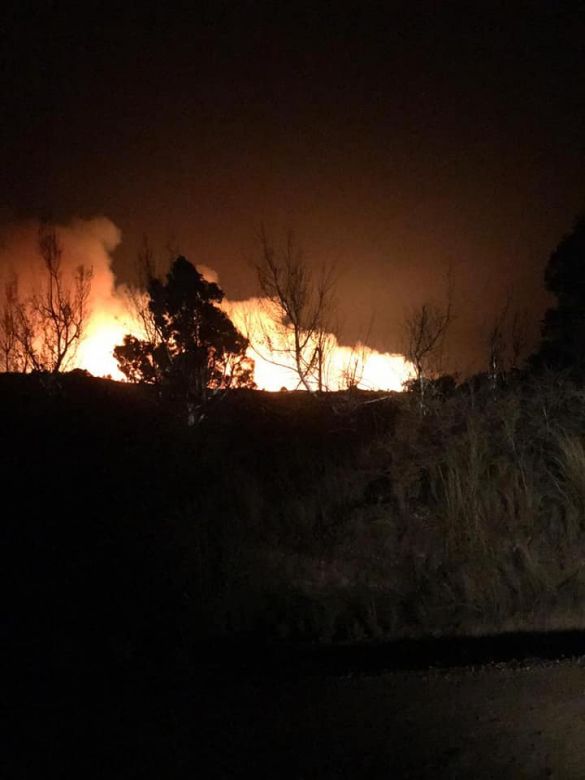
[114,257,254,404]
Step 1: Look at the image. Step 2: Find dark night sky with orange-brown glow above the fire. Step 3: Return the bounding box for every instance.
[0,0,585,368]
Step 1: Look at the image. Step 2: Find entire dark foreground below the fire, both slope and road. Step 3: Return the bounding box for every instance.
[6,376,585,780]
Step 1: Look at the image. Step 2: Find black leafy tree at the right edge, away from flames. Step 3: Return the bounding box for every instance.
[531,215,585,376]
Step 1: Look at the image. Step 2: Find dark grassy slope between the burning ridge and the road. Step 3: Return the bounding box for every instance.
[6,375,585,663]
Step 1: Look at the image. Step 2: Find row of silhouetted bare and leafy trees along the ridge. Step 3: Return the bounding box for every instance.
[0,217,585,402]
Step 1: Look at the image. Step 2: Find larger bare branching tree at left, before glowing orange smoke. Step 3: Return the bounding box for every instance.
[16,226,92,373]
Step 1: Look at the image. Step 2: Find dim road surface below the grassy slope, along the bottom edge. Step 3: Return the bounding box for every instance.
[9,634,585,780]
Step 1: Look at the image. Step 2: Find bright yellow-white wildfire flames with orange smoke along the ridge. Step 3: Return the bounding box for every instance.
[0,218,412,391]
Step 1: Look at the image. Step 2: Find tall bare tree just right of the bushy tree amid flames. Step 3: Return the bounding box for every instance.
[247,229,336,391]
